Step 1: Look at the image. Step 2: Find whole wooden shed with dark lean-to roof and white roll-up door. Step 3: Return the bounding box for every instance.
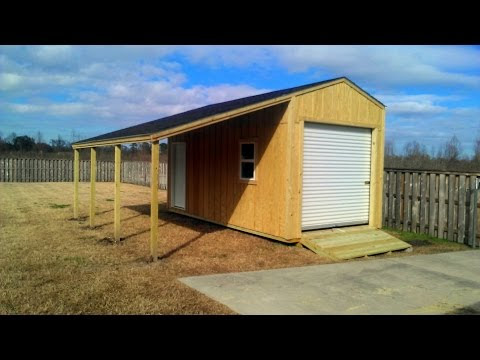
[73,77,410,257]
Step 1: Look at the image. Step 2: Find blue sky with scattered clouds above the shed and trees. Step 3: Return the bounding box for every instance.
[0,45,480,155]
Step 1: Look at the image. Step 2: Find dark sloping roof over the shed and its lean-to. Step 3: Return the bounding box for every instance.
[74,77,383,144]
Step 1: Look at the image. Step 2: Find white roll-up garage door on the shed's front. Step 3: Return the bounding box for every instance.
[302,122,372,230]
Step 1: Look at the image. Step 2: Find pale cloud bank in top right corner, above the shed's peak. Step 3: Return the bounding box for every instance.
[274,45,480,87]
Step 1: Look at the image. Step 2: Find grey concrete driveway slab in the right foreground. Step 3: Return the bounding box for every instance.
[180,250,480,315]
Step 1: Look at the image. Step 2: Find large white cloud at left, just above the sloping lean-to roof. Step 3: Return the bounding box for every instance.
[3,79,268,128]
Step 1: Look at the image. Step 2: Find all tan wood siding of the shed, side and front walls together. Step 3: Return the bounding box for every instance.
[169,82,385,241]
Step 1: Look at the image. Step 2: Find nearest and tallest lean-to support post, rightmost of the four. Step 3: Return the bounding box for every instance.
[150,140,160,261]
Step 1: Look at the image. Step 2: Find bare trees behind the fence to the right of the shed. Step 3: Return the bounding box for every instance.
[385,135,480,172]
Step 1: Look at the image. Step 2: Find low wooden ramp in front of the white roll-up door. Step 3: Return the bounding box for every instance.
[300,227,412,260]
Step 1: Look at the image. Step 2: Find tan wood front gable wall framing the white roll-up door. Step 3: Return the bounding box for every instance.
[288,82,385,238]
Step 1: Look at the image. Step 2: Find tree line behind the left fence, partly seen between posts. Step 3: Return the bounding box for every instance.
[0,131,167,161]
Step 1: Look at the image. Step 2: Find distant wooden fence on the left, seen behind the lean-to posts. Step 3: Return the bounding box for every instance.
[0,159,167,190]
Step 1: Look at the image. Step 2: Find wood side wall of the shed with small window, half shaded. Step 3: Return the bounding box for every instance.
[169,104,287,239]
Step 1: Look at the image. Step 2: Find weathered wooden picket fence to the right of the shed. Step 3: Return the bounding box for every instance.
[382,169,480,246]
